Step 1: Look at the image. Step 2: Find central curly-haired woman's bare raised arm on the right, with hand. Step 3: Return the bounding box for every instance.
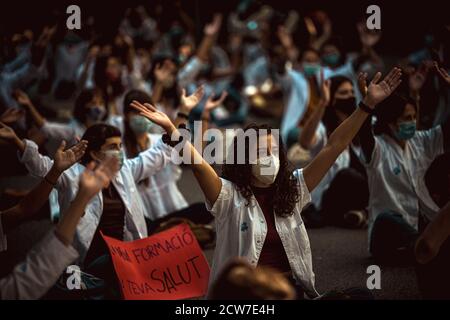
[304,68,401,192]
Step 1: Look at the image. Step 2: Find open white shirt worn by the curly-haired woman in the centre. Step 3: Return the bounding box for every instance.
[206,169,318,297]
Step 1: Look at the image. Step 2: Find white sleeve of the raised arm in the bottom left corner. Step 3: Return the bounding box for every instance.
[0,230,78,300]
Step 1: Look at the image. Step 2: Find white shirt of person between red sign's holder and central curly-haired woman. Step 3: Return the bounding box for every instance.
[128,134,188,220]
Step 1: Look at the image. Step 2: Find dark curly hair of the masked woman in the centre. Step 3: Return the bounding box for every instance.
[222,124,299,217]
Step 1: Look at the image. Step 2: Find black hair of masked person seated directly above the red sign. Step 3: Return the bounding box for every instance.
[80,123,122,165]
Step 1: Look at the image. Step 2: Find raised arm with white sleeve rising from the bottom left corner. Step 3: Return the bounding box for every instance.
[0,159,118,299]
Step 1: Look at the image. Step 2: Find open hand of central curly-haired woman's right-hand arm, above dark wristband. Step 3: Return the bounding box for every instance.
[364,67,402,108]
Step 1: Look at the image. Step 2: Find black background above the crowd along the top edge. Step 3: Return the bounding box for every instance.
[0,0,450,56]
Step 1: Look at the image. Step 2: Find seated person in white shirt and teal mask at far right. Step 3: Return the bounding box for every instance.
[360,66,450,263]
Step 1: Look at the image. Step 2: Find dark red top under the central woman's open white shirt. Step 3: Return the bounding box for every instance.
[252,187,291,273]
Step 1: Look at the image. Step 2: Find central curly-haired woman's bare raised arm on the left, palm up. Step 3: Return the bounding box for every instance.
[132,101,222,203]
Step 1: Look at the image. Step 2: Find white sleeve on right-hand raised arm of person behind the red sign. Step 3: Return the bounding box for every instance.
[125,139,173,182]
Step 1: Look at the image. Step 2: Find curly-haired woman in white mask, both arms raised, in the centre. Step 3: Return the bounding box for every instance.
[132,68,401,297]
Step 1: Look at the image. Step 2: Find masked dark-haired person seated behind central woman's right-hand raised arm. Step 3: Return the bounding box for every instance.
[299,72,369,228]
